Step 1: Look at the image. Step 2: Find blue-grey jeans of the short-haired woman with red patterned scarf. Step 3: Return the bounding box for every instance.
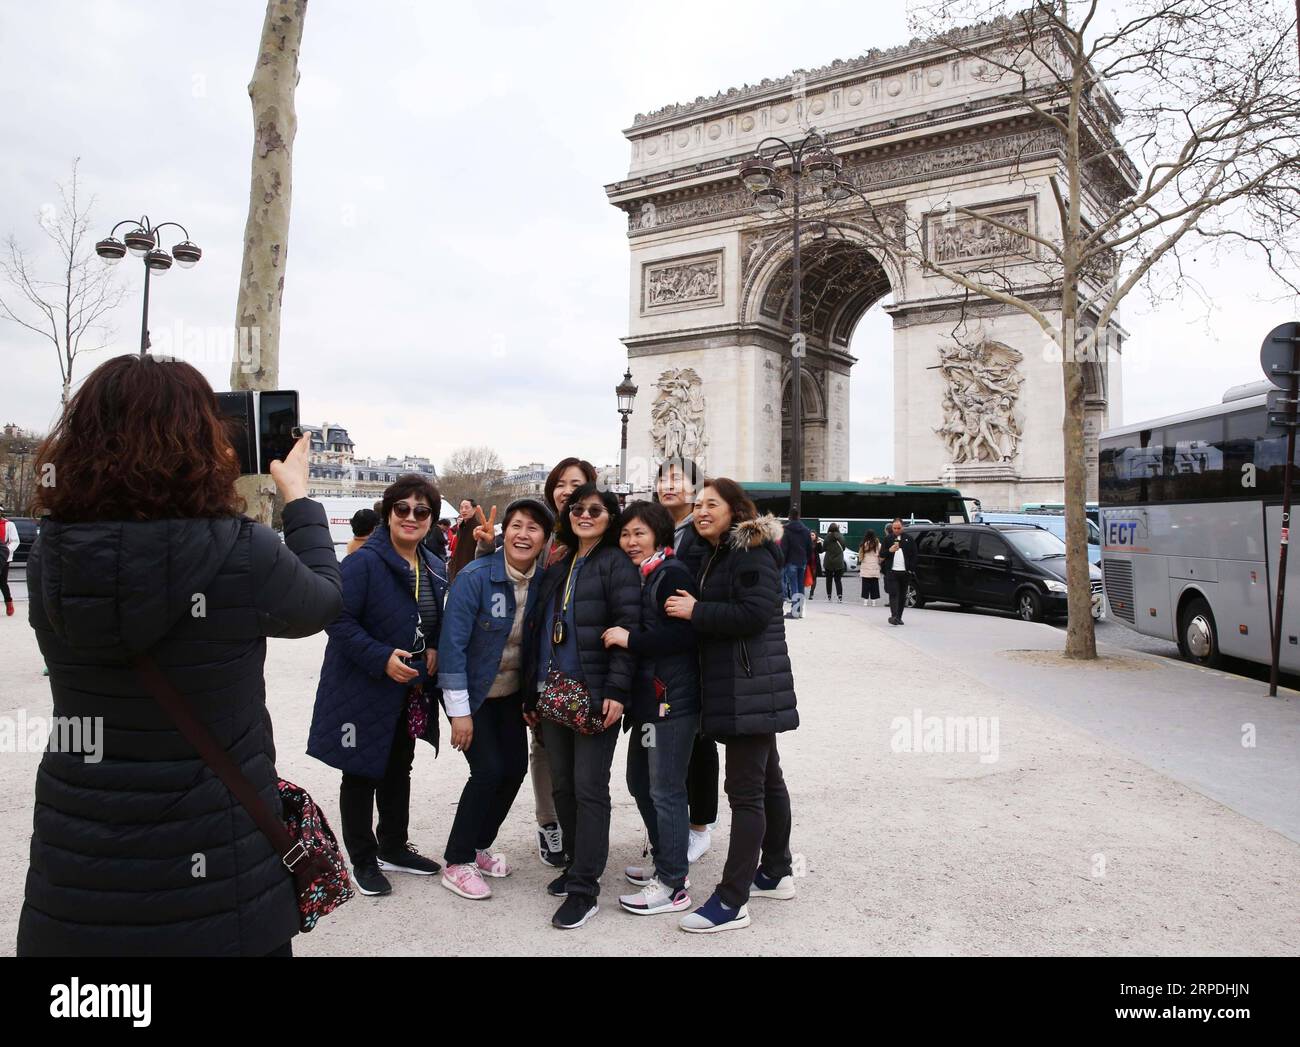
[628,717,716,891]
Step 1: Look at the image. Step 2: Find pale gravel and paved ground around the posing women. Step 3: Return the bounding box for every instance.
[0,593,1300,956]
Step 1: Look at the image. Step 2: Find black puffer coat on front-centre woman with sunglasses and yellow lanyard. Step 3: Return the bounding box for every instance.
[524,545,641,713]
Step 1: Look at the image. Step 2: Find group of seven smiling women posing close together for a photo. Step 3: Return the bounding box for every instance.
[308,458,798,933]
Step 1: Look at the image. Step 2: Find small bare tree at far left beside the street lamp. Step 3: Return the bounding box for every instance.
[0,157,126,404]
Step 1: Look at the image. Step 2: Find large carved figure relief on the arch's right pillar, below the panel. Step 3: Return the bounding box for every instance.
[935,341,1024,464]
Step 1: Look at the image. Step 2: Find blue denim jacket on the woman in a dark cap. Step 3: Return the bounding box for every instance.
[438,549,542,715]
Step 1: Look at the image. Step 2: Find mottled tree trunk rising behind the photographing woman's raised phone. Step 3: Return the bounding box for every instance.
[230,0,307,524]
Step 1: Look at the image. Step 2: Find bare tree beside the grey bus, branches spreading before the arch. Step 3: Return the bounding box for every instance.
[826,0,1300,658]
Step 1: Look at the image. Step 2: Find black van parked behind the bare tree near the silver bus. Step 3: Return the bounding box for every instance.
[904,524,1101,622]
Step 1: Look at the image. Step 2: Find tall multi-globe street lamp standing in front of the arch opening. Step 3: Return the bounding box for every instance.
[740,127,842,512]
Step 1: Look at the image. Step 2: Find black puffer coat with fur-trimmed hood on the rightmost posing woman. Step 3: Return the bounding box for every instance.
[690,515,800,739]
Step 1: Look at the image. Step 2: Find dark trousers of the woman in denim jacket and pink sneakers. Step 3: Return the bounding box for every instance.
[446,693,528,865]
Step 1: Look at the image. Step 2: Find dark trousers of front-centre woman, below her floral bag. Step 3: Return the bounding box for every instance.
[542,721,619,897]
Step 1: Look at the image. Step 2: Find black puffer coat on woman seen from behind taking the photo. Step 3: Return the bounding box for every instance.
[18,498,343,956]
